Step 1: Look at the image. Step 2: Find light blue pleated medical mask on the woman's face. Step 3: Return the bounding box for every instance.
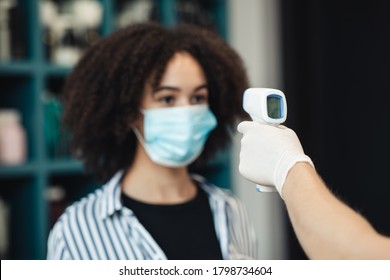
[134,105,217,167]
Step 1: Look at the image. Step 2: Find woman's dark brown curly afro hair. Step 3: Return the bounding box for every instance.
[61,23,248,184]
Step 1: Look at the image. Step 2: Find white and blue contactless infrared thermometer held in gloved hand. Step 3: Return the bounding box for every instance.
[242,88,287,192]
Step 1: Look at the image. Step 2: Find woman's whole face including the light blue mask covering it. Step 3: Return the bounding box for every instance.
[134,52,217,168]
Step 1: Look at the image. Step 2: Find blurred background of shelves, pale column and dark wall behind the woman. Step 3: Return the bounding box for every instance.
[0,0,390,259]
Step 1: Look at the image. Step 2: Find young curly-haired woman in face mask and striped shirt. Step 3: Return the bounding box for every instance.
[48,23,257,259]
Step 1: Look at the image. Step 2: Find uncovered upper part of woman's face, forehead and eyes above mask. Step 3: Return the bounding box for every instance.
[141,52,208,109]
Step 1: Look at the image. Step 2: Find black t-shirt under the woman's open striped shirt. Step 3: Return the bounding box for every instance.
[122,187,222,260]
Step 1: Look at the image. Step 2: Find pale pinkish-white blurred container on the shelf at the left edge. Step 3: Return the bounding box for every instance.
[0,109,27,165]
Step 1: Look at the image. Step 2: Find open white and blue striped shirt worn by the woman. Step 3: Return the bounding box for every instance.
[47,172,257,260]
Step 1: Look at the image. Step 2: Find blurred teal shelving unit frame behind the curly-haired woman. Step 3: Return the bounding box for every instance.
[0,0,230,260]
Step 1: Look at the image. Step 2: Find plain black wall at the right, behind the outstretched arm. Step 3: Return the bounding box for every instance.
[281,0,390,259]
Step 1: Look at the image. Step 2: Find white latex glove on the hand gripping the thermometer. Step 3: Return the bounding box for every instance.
[237,121,314,196]
